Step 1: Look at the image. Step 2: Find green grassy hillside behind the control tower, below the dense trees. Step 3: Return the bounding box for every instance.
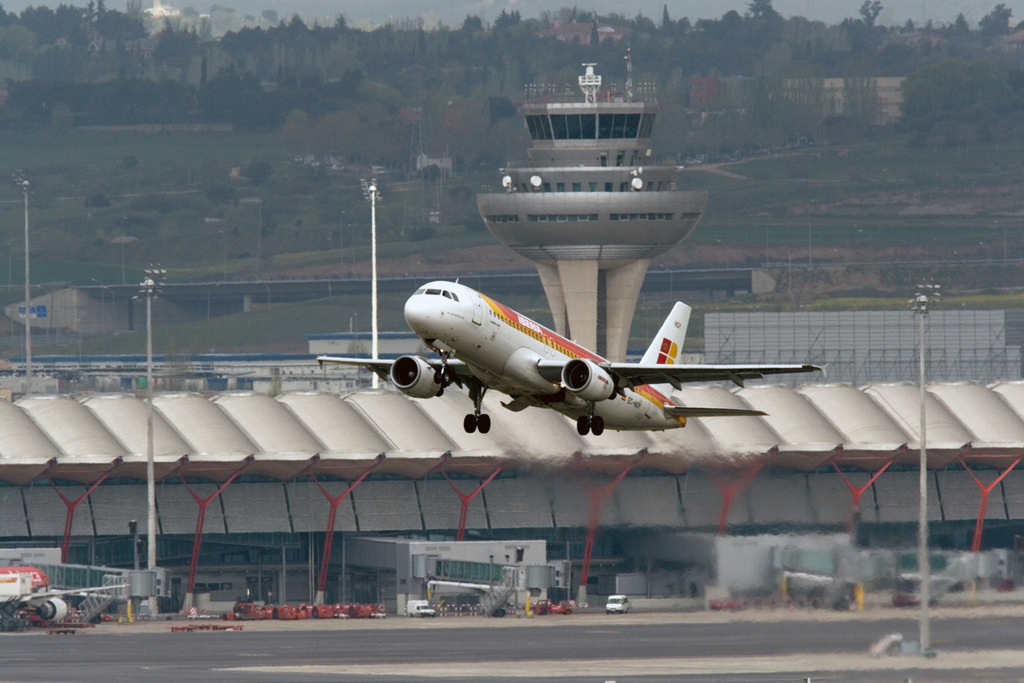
[0,129,1024,352]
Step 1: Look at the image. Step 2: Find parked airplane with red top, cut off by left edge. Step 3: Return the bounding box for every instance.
[0,565,123,631]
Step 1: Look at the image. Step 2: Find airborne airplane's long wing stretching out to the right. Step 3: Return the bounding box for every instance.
[538,360,821,393]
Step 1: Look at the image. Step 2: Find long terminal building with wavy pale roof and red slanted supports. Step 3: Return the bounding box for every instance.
[0,381,1024,613]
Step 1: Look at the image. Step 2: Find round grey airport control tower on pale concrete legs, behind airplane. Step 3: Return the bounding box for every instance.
[476,62,708,360]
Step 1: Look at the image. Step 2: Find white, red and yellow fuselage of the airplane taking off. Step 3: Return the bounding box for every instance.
[406,281,683,430]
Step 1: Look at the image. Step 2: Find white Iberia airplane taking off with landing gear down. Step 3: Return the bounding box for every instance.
[316,281,820,435]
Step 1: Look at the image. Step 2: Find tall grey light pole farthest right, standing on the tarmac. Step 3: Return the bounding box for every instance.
[910,284,941,656]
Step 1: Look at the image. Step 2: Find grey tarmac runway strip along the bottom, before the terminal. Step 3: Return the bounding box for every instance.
[0,606,1024,683]
